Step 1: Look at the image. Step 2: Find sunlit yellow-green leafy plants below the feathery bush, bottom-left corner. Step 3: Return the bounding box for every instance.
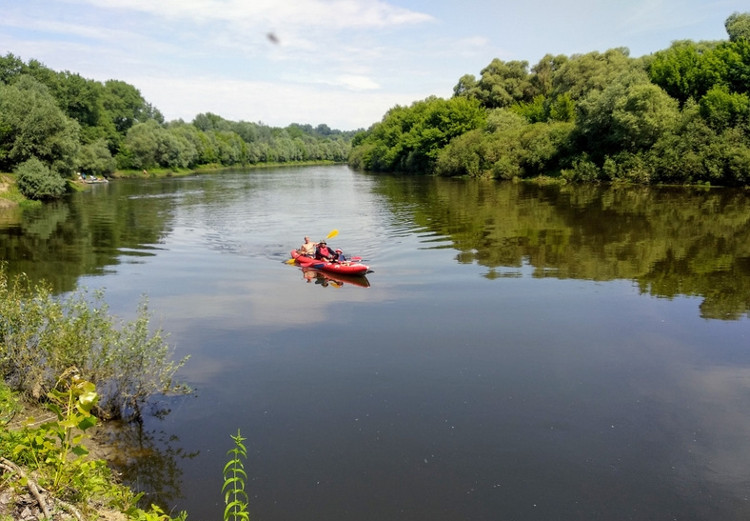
[0,376,187,521]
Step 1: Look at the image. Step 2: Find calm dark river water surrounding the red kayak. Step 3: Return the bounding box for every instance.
[0,166,750,521]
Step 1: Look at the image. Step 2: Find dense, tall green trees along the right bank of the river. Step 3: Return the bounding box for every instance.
[349,13,750,186]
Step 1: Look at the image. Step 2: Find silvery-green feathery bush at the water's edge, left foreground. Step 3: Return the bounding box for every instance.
[0,266,188,420]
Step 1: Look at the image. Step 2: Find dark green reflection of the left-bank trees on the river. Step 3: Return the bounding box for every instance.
[0,183,175,292]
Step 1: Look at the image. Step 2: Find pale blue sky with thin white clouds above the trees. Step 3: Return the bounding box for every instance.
[0,0,750,130]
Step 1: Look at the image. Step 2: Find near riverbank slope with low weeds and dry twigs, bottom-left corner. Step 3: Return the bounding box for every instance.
[0,368,184,521]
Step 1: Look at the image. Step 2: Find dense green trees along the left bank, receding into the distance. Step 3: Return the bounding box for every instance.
[0,54,354,199]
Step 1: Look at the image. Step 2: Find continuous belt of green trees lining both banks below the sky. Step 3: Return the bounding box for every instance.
[0,13,750,200]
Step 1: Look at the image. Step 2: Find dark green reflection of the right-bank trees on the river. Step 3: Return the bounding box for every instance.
[378,177,750,320]
